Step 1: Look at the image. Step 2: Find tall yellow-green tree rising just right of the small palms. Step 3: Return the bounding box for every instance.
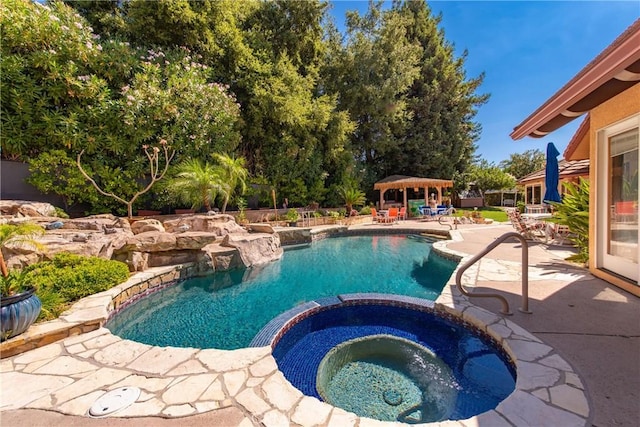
[237,1,352,204]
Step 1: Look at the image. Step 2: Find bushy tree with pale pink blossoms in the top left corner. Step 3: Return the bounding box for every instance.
[0,0,109,160]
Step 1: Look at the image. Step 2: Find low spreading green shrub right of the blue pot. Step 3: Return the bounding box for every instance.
[26,253,129,320]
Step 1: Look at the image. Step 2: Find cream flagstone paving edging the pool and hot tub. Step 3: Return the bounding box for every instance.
[0,230,590,427]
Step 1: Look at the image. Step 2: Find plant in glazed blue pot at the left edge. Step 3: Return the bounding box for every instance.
[0,223,44,341]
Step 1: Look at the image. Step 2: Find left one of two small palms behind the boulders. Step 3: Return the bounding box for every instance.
[167,159,229,211]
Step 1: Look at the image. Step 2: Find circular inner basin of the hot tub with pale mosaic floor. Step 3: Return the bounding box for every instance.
[316,334,458,423]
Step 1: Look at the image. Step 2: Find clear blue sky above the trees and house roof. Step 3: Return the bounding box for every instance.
[330,0,640,163]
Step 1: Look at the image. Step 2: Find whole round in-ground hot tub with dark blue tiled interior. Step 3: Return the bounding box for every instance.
[253,294,515,423]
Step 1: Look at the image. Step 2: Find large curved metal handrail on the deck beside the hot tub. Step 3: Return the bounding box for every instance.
[456,231,531,315]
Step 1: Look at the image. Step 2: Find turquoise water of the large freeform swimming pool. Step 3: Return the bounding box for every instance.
[106,235,455,349]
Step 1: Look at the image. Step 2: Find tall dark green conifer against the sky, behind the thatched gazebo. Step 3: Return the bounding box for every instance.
[387,1,488,179]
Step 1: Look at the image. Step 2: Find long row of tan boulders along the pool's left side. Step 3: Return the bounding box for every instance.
[2,210,283,272]
